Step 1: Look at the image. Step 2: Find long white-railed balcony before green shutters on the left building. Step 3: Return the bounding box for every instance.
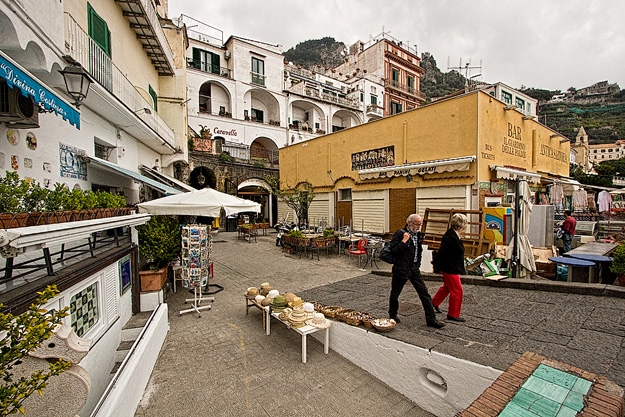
[65,13,174,146]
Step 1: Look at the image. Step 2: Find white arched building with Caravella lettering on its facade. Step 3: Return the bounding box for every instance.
[177,15,384,158]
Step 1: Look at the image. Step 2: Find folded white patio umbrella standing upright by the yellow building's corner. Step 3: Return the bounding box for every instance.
[506,181,536,278]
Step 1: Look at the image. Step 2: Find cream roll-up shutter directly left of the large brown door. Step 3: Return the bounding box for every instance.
[352,190,388,234]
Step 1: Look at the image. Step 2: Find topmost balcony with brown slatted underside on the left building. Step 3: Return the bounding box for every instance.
[115,0,174,75]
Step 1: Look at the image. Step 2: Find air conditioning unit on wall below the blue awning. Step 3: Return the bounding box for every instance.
[0,80,39,129]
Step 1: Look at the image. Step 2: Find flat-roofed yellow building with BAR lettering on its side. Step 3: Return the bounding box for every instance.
[279,91,570,234]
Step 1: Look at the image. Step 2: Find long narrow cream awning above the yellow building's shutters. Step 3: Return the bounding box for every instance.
[358,155,475,180]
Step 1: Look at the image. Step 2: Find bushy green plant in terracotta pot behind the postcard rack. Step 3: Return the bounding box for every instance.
[137,216,181,292]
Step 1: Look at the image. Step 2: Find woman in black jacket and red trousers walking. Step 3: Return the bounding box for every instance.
[432,213,469,323]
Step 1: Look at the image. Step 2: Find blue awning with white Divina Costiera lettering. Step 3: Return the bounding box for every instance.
[0,51,80,130]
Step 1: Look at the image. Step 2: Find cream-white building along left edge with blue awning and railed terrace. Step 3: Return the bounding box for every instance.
[0,0,188,415]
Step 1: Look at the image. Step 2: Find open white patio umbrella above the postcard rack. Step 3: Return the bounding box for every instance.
[137,188,260,217]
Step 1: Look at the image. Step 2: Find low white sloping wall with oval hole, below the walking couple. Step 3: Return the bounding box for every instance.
[313,322,503,417]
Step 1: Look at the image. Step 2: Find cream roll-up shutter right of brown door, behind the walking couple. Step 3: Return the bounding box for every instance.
[417,186,467,234]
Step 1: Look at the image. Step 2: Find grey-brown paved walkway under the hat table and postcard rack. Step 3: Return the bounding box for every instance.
[135,232,432,417]
